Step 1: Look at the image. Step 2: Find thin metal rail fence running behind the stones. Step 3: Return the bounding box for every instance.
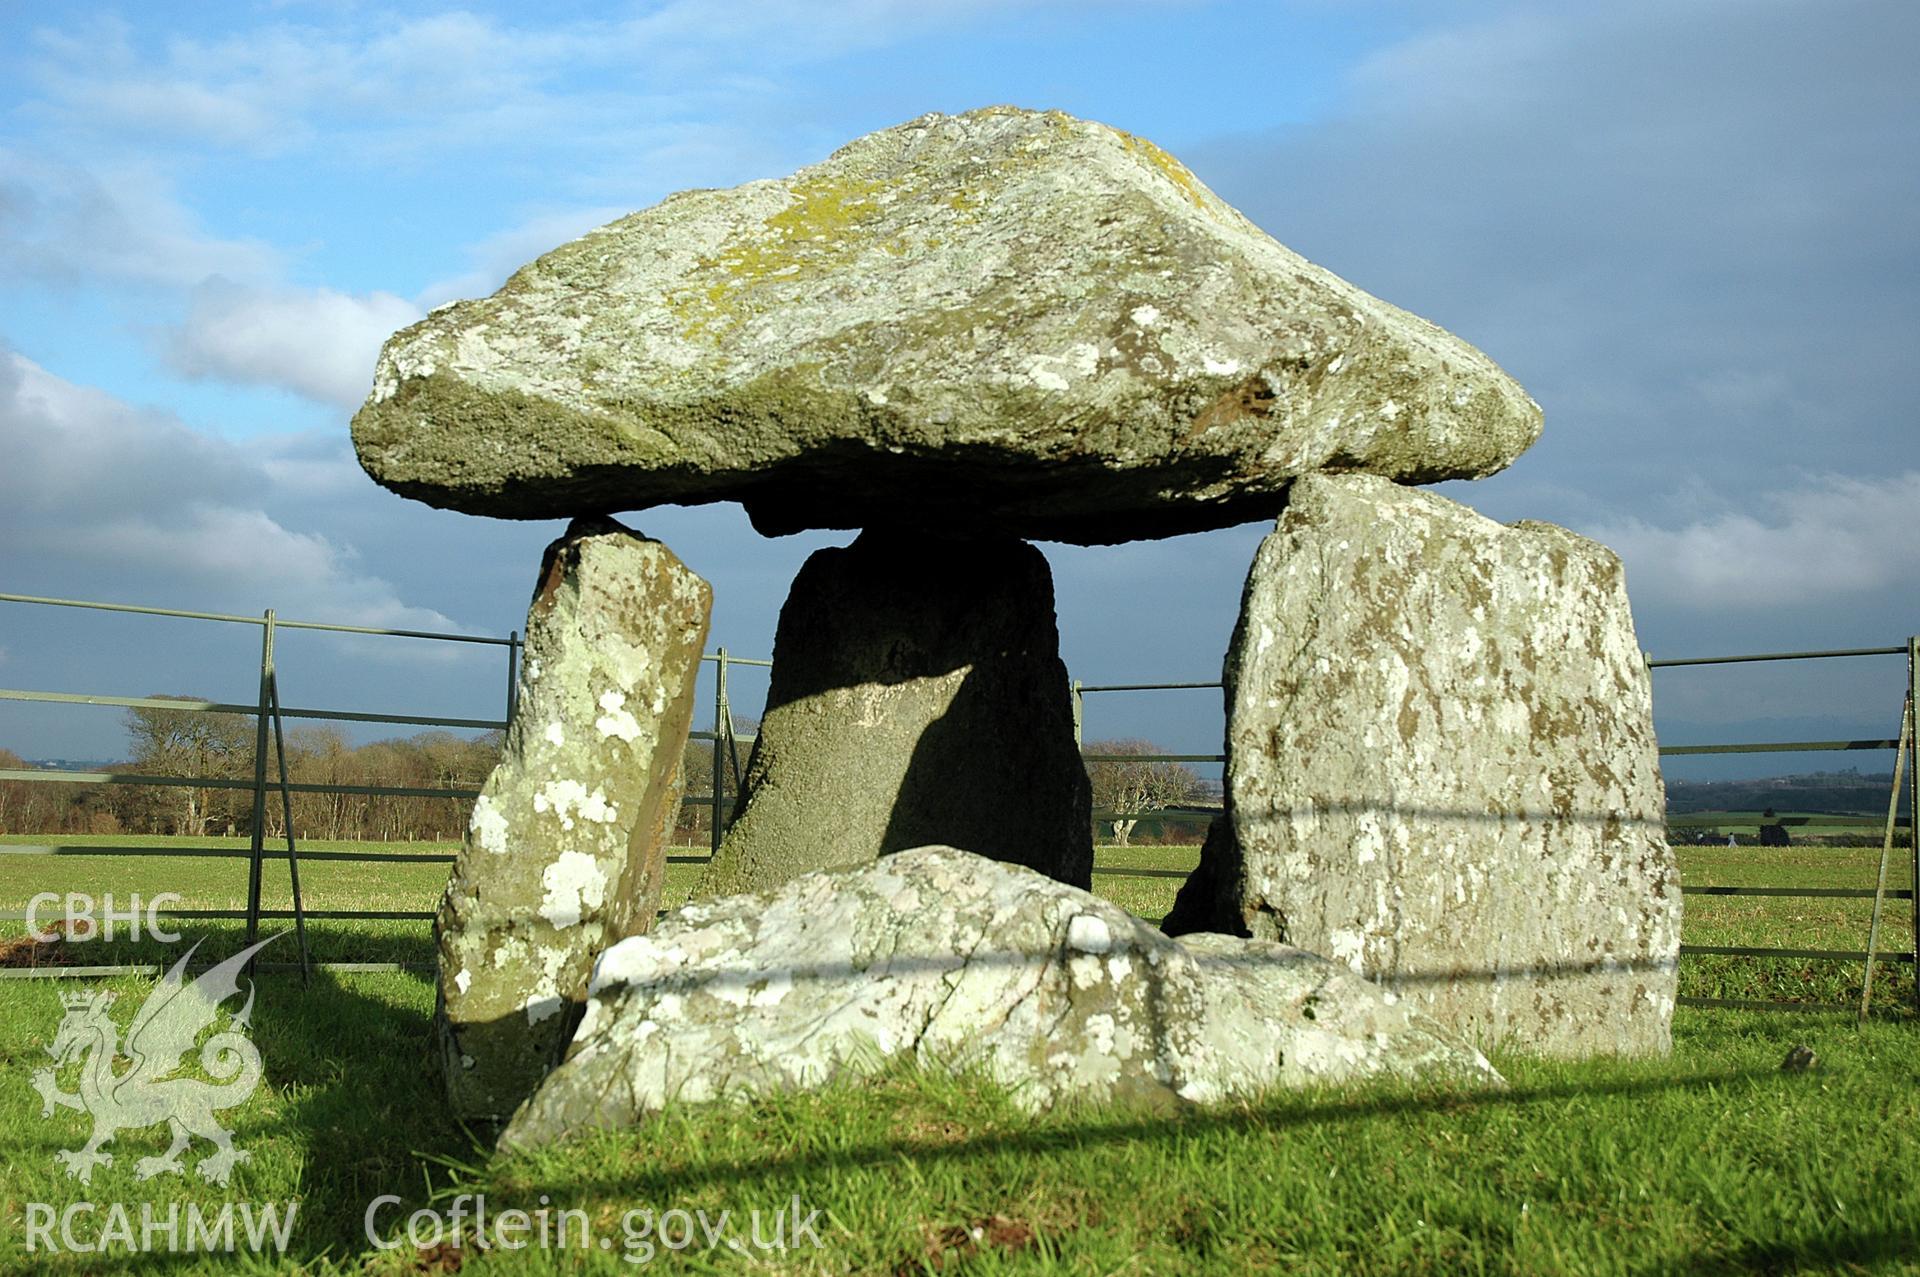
[0,593,1920,1016]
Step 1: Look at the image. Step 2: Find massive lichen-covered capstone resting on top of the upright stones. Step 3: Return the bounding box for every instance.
[353,108,1540,542]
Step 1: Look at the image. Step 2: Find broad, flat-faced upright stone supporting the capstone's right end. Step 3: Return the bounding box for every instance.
[1173,474,1680,1054]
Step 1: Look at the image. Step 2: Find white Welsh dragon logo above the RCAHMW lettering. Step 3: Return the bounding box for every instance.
[33,935,278,1185]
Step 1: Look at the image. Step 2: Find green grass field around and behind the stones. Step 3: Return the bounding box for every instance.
[0,837,1920,1273]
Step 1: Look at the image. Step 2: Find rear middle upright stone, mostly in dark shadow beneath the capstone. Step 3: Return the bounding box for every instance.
[701,528,1092,895]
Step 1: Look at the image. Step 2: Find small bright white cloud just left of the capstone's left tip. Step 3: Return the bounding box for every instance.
[163,280,422,407]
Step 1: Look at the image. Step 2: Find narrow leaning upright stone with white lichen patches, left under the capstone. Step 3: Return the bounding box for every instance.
[434,518,712,1123]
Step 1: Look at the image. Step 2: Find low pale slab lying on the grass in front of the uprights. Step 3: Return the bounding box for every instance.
[505,847,1500,1144]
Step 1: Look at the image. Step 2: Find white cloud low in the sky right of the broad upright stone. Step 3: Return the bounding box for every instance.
[1586,470,1920,613]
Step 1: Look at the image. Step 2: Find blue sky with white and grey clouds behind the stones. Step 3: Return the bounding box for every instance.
[0,0,1920,774]
